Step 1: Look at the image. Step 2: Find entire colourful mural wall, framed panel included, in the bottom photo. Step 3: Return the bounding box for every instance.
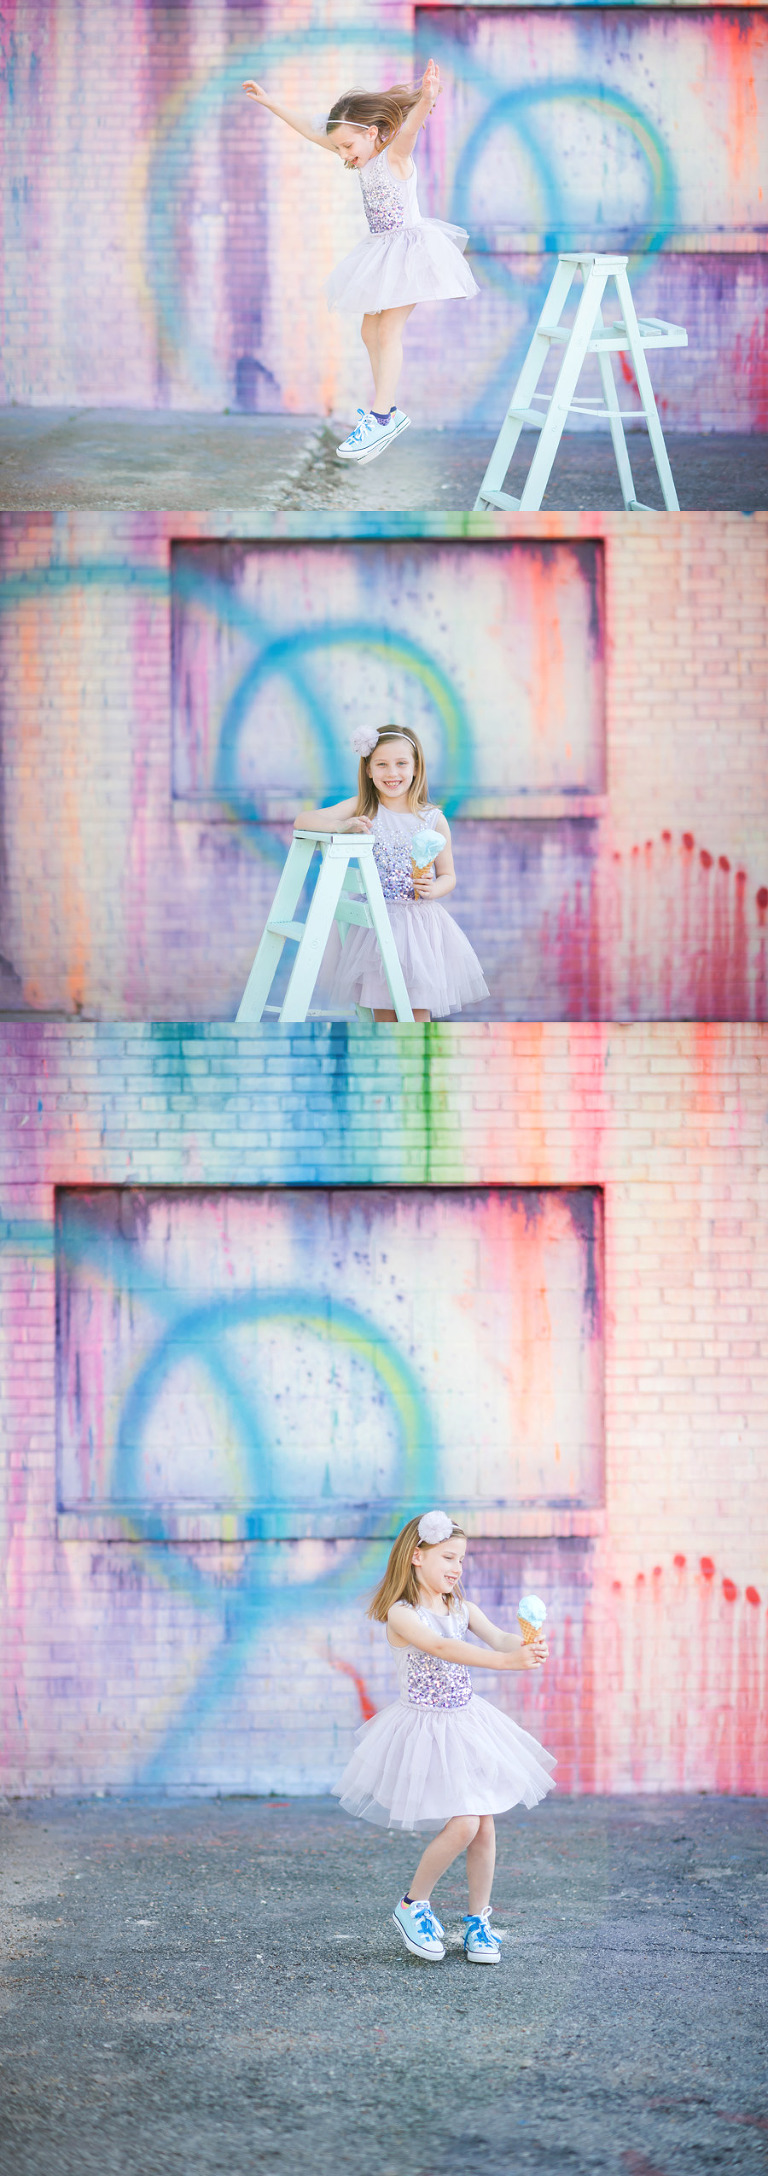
[0,1021,768,1793]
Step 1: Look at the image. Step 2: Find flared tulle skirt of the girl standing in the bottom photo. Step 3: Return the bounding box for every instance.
[333,1693,557,1830]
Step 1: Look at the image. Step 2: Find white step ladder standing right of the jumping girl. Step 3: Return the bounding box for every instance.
[474,250,688,514]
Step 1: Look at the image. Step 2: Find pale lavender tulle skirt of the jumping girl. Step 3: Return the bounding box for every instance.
[326,220,479,316]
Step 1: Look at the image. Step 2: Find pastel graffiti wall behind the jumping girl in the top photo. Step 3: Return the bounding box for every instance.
[2,0,768,431]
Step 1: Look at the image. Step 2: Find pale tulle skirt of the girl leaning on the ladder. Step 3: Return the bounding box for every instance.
[322,899,490,1018]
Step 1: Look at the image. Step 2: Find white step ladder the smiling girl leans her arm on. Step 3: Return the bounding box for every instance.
[237,831,413,1021]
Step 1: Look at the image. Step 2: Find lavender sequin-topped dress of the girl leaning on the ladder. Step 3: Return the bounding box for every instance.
[322,805,490,1018]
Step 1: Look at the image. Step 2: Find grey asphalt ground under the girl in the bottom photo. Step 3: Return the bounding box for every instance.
[0,1797,768,2176]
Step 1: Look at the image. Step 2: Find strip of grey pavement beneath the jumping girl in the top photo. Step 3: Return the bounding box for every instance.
[0,407,768,514]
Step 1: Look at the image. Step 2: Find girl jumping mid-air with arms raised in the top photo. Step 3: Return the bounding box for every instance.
[244,61,479,461]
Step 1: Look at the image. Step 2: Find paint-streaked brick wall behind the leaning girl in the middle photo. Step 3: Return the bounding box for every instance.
[0,514,768,1021]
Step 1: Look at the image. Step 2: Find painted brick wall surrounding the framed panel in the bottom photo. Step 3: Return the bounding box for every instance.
[0,1023,768,1793]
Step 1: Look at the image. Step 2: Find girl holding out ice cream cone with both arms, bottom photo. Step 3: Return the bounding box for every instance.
[333,1510,555,1965]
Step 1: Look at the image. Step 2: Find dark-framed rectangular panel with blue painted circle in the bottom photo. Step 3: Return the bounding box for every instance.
[57,1188,603,1536]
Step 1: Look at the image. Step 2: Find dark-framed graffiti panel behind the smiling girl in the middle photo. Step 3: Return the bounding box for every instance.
[172,540,605,818]
